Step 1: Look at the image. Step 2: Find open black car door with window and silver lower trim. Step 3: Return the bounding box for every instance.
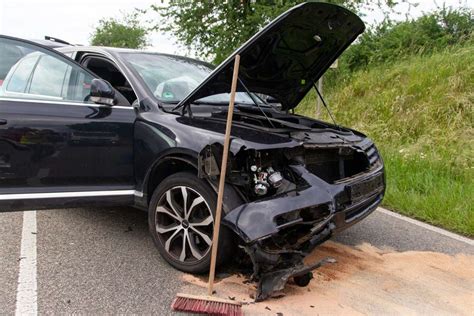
[0,36,136,211]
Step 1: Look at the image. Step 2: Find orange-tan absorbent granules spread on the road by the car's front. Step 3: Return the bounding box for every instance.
[183,241,474,315]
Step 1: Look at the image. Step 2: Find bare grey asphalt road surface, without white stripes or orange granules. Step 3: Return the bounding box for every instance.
[0,208,474,315]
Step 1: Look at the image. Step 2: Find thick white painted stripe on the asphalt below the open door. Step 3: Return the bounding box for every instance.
[15,211,38,315]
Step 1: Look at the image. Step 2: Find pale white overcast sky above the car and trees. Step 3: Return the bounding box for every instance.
[0,0,474,55]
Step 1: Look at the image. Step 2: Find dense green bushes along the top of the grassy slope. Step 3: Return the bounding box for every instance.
[341,8,474,72]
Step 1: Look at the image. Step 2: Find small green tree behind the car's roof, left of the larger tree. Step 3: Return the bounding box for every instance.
[91,10,148,48]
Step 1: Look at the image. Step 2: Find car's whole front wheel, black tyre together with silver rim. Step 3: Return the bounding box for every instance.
[148,172,234,273]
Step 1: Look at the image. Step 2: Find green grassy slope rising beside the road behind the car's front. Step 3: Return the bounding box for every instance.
[298,43,474,236]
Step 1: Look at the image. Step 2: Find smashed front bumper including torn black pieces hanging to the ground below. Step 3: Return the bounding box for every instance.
[223,162,385,301]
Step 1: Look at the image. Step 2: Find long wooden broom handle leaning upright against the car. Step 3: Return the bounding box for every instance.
[207,55,240,295]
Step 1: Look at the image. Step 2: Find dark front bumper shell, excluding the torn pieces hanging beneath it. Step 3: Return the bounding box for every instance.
[223,163,385,244]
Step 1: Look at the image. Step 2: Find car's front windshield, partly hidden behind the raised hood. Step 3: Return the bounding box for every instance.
[121,53,260,104]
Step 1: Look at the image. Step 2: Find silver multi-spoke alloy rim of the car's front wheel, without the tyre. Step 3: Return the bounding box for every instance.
[155,186,214,264]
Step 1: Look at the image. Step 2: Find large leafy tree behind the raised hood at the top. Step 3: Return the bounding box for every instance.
[151,0,407,63]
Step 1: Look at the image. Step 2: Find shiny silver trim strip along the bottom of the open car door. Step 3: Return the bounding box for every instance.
[0,190,137,201]
